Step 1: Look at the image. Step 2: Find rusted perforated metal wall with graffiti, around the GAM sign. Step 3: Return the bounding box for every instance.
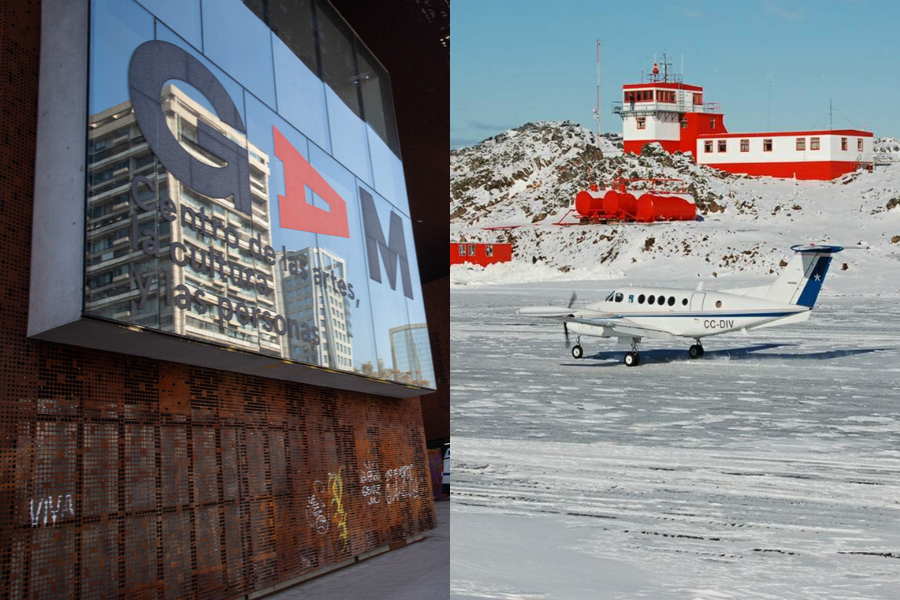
[0,1,434,599]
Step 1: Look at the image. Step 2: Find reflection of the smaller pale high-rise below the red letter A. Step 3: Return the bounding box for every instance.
[276,246,353,370]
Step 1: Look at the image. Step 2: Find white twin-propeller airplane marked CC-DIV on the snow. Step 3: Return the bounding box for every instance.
[518,245,849,367]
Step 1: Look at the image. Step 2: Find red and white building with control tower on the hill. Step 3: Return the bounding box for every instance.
[613,65,873,179]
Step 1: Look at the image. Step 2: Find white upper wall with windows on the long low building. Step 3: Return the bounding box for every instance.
[697,133,872,165]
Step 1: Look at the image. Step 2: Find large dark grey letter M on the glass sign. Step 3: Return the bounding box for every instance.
[359,188,413,299]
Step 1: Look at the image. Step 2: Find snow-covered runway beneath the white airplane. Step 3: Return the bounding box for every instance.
[451,283,900,600]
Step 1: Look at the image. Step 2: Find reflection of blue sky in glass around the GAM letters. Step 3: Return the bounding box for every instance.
[89,0,434,384]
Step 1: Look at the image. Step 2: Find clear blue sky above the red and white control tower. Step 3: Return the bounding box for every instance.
[450,0,900,148]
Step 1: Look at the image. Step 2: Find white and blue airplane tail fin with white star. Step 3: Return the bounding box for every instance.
[764,245,844,308]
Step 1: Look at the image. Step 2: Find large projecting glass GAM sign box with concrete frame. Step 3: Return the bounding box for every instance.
[29,0,435,395]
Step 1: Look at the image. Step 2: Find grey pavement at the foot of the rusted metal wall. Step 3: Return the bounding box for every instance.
[264,500,450,600]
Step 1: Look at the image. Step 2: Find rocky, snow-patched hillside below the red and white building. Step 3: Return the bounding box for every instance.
[450,122,900,288]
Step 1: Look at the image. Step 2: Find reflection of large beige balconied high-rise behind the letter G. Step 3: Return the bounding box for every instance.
[85,85,281,355]
